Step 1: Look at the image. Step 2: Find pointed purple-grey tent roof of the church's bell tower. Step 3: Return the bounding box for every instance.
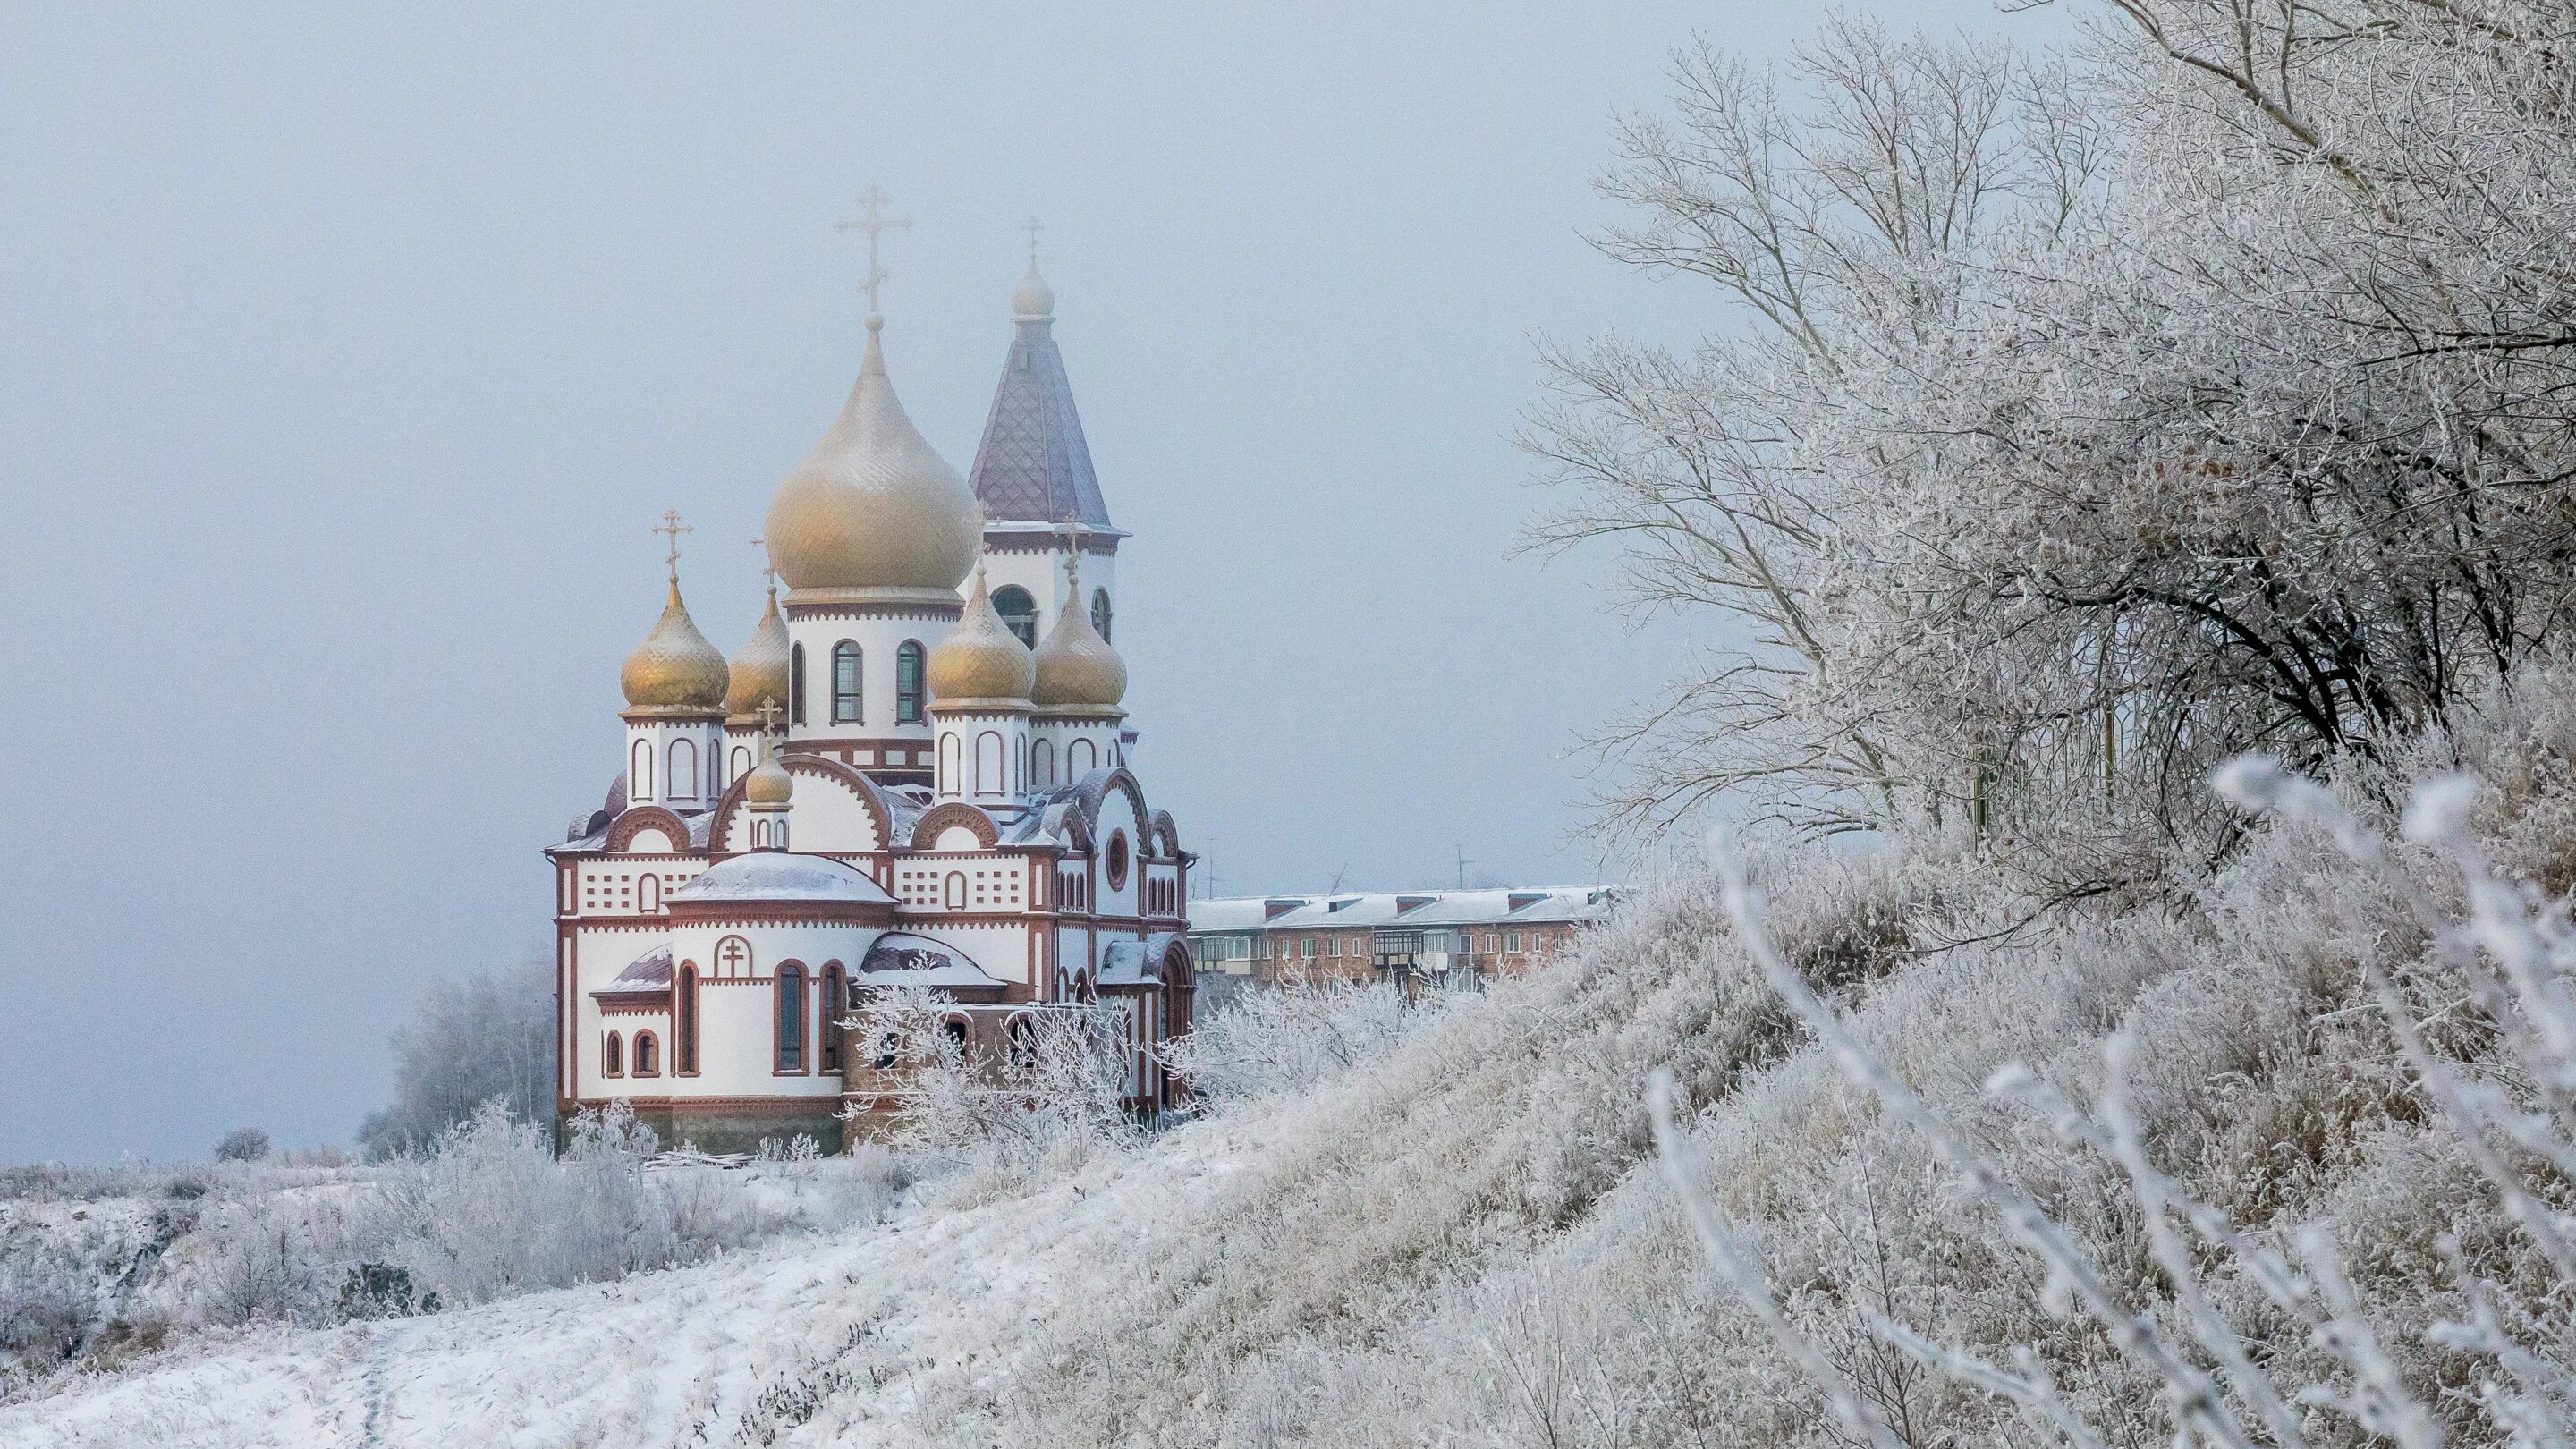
[966,258,1115,534]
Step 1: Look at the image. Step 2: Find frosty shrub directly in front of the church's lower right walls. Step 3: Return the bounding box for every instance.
[852,987,1133,1168]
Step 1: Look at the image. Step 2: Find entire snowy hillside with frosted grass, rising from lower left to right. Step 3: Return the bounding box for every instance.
[0,675,2576,1446]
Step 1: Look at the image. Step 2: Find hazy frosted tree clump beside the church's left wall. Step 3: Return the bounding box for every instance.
[358,962,554,1157]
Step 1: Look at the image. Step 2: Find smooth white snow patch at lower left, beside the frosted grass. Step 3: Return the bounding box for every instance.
[0,1124,1229,1449]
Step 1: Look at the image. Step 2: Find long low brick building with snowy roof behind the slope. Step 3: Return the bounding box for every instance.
[1191,885,1618,985]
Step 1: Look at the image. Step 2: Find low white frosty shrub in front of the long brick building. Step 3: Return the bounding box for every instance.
[1162,977,1443,1106]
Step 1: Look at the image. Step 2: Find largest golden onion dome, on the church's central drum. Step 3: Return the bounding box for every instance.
[762,318,984,592]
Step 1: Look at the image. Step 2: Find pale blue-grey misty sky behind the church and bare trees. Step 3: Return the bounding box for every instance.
[0,0,2029,1160]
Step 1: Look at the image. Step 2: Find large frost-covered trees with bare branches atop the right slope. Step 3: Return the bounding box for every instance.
[1528,0,2576,866]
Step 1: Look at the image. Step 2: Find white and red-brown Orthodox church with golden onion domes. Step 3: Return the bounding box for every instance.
[547,240,1192,1150]
